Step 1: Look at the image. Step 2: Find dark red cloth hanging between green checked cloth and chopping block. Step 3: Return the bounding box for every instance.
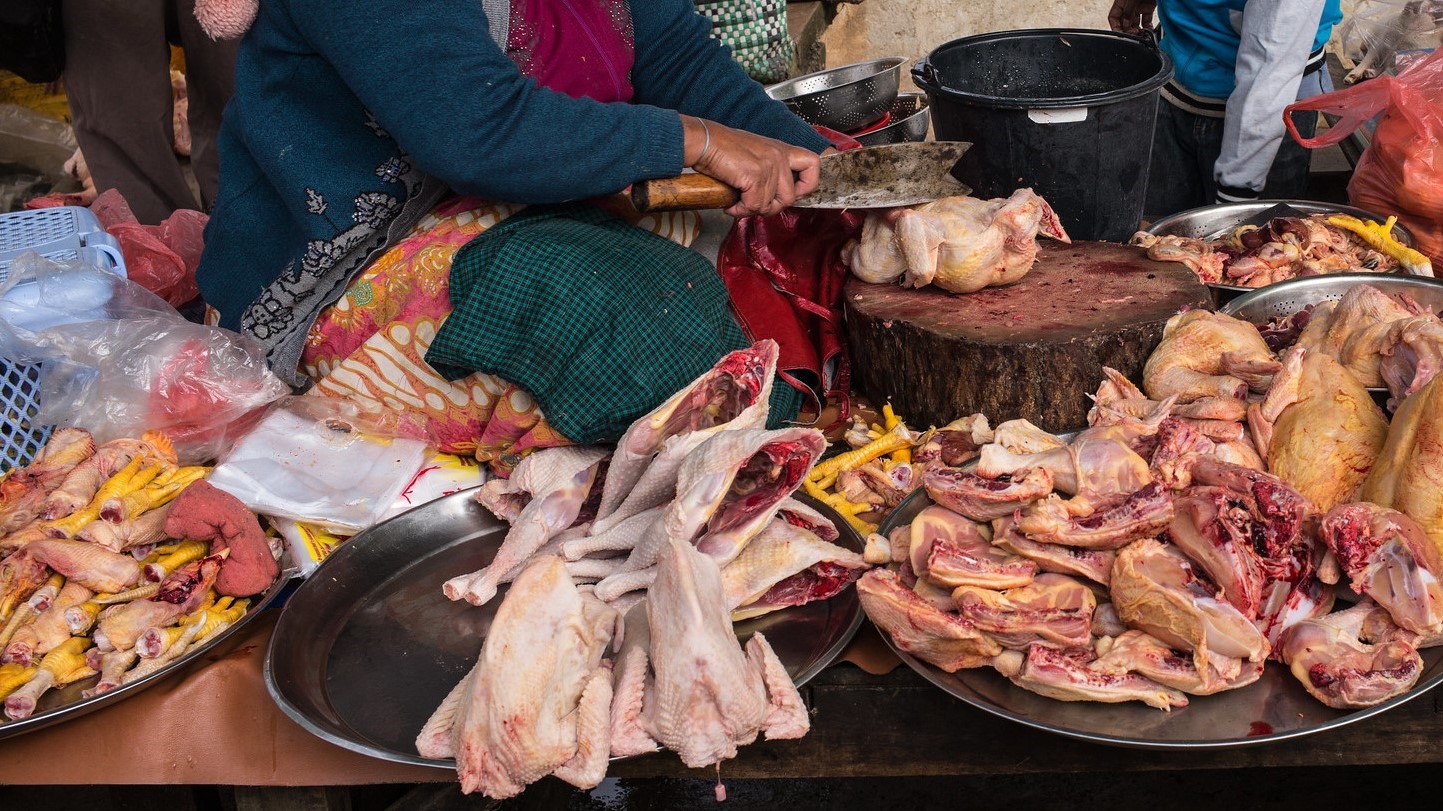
[717,127,867,420]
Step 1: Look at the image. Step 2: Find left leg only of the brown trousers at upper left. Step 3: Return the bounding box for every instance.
[62,0,195,225]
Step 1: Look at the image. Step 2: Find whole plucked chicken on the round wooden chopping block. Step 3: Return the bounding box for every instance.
[846,189,1071,293]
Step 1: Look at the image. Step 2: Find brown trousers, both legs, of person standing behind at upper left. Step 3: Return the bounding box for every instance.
[63,0,238,225]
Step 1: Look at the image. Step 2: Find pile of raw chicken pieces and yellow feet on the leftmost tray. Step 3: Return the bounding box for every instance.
[0,429,280,720]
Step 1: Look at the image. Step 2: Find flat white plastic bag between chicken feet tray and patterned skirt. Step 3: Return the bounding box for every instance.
[209,397,430,534]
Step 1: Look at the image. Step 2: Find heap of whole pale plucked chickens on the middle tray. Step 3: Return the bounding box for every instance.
[417,341,866,798]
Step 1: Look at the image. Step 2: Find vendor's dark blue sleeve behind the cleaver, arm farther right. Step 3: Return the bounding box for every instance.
[631,0,831,152]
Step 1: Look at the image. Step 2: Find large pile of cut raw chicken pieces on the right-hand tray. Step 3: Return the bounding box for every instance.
[857,303,1443,709]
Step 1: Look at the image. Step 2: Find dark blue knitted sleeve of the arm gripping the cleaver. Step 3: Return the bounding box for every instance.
[290,0,696,203]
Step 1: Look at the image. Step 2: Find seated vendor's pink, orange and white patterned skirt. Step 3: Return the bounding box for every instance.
[302,196,701,475]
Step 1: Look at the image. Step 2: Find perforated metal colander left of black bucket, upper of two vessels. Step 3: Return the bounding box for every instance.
[766,56,906,133]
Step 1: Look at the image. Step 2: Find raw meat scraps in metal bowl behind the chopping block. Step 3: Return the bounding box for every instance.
[1131,214,1398,287]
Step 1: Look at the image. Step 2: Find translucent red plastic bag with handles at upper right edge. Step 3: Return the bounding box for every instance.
[1284,49,1443,264]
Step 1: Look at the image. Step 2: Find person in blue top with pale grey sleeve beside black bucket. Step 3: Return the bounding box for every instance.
[1108,0,1342,218]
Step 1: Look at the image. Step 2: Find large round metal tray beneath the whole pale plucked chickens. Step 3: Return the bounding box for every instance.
[266,489,863,769]
